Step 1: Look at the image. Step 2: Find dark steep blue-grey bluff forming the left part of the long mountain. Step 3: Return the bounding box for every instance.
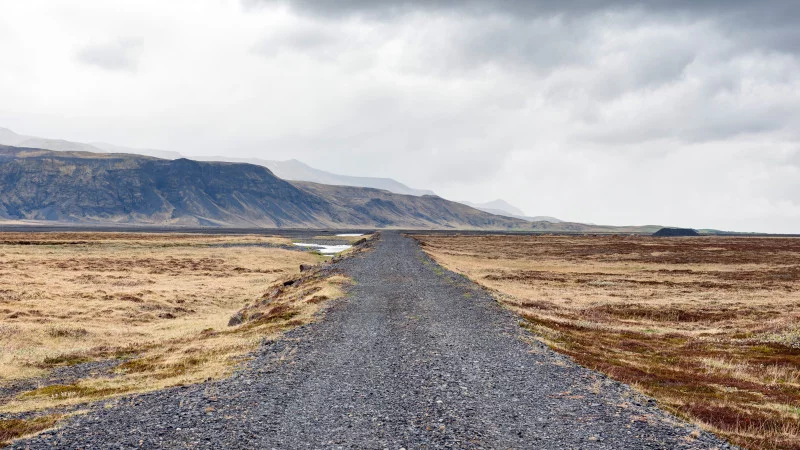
[0,147,329,227]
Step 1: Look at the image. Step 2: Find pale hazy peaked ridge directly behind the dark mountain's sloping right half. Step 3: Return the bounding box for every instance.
[201,156,436,195]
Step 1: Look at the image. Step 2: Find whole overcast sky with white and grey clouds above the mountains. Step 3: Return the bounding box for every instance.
[0,0,800,233]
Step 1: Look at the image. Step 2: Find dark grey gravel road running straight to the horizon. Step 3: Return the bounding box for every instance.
[12,232,729,449]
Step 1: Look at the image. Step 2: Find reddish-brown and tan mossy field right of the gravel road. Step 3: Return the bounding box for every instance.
[415,235,800,449]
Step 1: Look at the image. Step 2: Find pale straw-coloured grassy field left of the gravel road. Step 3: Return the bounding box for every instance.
[0,233,346,441]
